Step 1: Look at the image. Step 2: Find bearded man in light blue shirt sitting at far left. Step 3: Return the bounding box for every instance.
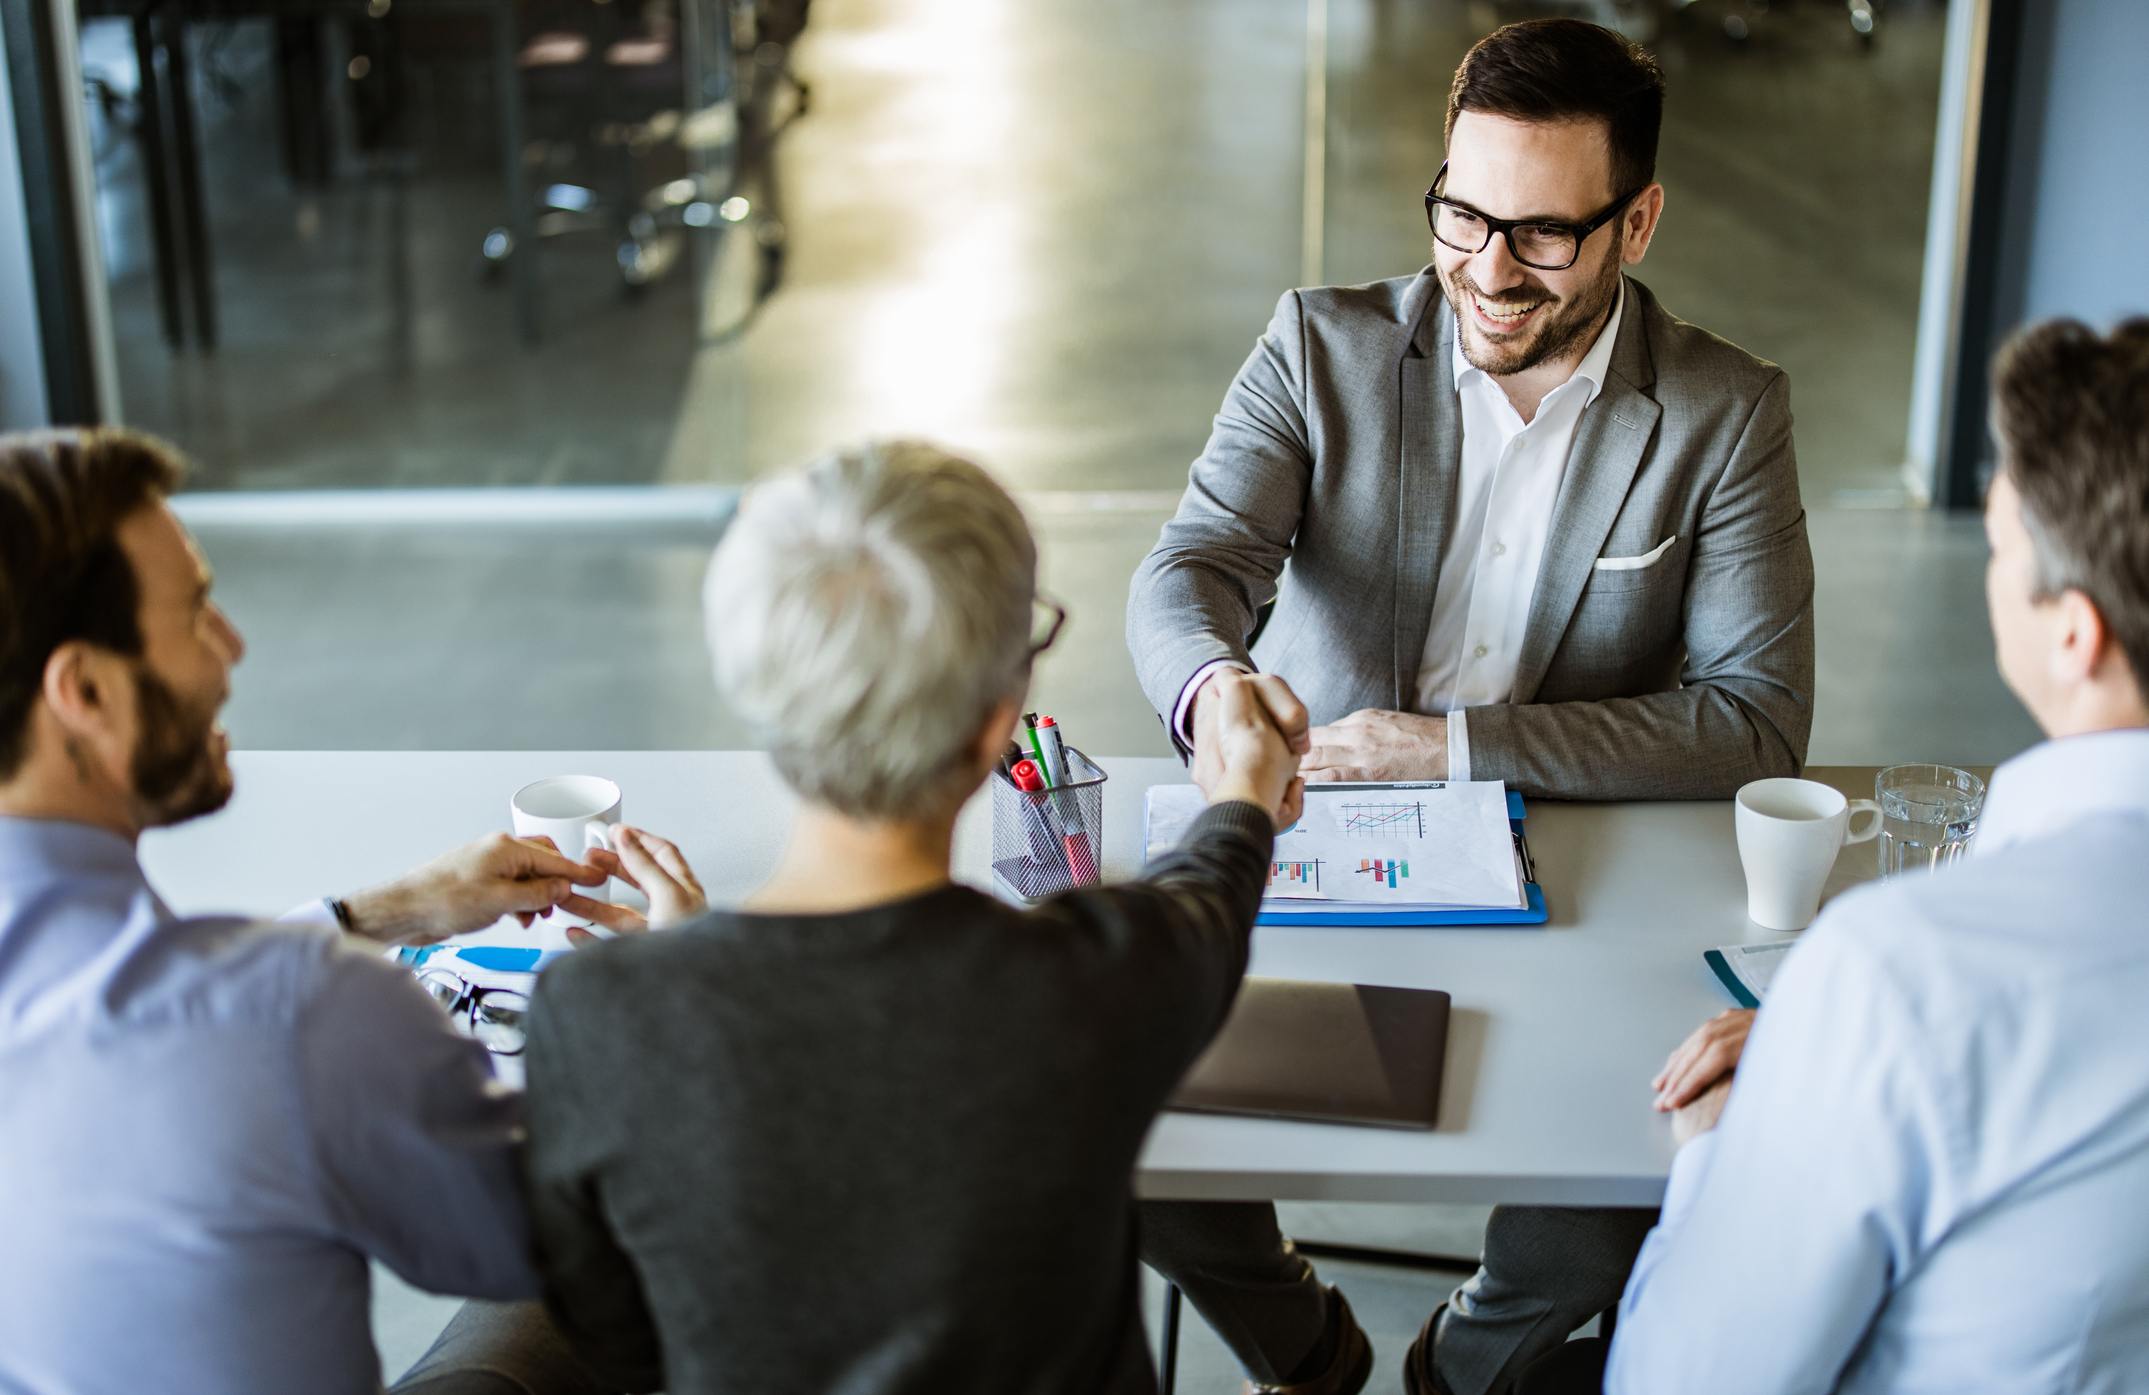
[0,430,617,1395]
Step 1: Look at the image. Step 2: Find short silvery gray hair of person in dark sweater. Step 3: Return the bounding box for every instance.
[703,441,1038,819]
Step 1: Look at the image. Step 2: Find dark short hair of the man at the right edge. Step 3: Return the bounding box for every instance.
[1992,318,2149,684]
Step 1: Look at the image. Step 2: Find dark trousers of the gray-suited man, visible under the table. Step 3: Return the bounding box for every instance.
[1141,1202,1657,1395]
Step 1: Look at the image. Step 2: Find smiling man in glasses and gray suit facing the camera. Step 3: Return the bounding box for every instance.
[1126,19,1814,1395]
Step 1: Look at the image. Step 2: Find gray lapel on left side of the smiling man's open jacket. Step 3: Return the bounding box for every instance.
[1390,275,1463,711]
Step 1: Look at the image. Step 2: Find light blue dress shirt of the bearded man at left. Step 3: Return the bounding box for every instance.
[0,817,537,1395]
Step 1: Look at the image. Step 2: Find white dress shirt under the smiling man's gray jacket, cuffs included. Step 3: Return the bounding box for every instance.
[1171,277,1627,780]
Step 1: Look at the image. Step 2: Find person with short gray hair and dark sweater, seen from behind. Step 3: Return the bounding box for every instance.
[529,443,1307,1395]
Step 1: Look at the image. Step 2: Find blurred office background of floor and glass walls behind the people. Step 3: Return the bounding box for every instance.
[0,0,2149,1389]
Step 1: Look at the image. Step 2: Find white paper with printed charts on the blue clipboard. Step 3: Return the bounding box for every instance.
[1148,780,1524,916]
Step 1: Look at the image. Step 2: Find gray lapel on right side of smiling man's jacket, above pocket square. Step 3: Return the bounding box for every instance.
[1513,294,1663,703]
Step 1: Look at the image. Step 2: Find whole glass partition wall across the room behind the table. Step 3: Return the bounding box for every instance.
[33,0,1945,503]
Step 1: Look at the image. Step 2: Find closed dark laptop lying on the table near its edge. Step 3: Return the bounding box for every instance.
[1167,978,1448,1128]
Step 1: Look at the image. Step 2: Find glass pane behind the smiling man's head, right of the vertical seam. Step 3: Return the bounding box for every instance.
[1315,0,1947,507]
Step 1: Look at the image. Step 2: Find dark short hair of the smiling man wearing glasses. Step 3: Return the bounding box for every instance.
[1442,19,1663,198]
